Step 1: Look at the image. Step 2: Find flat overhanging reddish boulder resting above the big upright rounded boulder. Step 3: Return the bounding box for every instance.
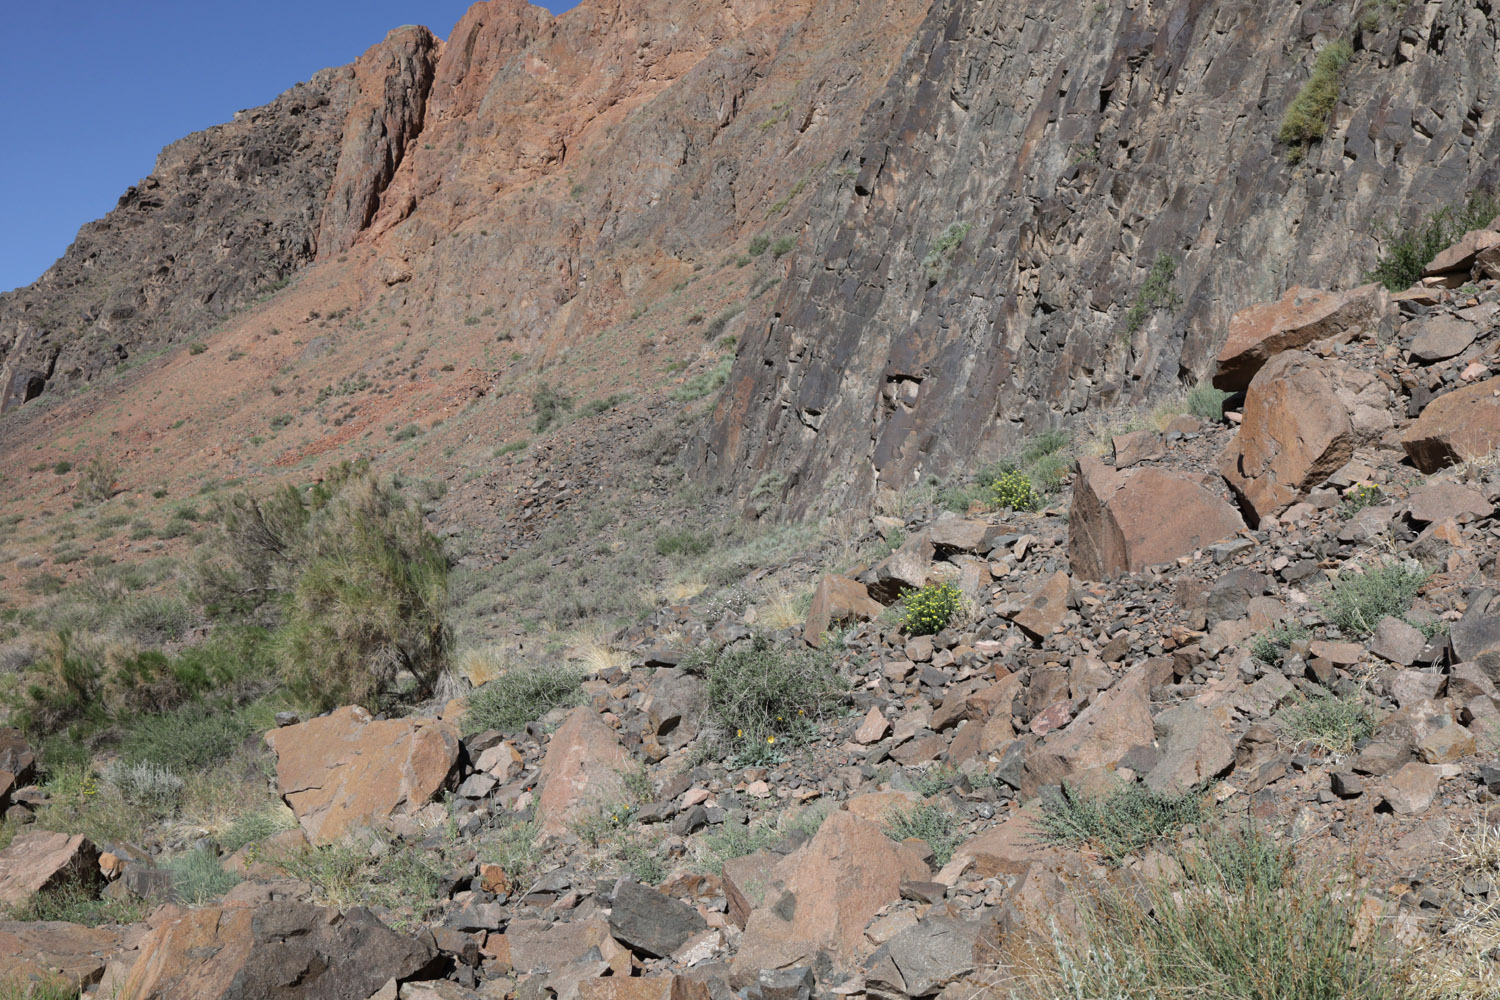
[1214,285,1389,391]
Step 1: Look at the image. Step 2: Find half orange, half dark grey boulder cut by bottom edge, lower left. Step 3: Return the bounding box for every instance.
[120,901,438,1000]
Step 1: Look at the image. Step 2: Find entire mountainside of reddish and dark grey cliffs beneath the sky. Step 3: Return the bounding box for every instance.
[0,0,1500,510]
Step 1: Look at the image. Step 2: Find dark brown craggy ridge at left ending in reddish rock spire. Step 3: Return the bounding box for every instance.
[0,28,435,409]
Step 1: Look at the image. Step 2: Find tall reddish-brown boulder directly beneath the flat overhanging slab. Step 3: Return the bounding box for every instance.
[1220,354,1391,522]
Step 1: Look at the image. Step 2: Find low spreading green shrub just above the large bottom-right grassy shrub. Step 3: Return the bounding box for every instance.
[1037,783,1205,865]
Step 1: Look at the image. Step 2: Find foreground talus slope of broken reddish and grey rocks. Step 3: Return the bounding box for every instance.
[0,239,1500,1000]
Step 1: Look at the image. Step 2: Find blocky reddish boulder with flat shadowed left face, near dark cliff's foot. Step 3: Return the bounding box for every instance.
[1068,459,1245,580]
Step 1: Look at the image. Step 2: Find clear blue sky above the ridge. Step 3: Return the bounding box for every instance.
[0,0,573,291]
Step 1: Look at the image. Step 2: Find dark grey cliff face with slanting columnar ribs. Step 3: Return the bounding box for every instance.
[699,0,1500,508]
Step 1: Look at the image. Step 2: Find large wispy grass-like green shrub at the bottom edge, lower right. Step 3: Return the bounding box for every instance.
[1020,834,1416,1000]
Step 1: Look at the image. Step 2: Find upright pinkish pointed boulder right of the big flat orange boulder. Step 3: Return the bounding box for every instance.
[537,706,630,837]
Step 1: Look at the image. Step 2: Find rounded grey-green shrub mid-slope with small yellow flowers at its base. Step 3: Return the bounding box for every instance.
[684,634,848,754]
